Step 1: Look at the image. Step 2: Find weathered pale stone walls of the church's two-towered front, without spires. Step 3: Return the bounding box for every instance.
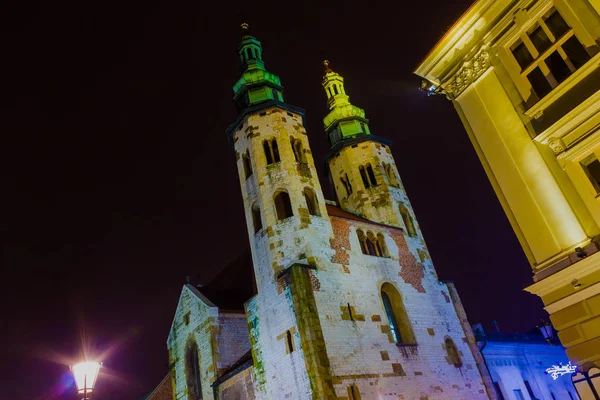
[227,104,487,399]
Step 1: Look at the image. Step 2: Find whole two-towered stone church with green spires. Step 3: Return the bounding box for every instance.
[148,24,496,400]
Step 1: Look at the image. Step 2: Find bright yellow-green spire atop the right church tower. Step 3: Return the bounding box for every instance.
[322,60,371,146]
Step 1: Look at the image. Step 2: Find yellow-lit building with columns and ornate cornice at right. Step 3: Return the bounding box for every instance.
[415,0,600,398]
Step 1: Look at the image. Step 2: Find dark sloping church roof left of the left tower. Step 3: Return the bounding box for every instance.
[198,248,256,311]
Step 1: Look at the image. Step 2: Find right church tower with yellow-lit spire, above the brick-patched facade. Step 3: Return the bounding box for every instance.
[322,61,421,238]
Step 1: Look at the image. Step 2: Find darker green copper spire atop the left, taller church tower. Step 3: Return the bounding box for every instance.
[233,23,283,111]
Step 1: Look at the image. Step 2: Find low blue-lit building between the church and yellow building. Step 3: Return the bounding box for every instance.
[475,329,579,400]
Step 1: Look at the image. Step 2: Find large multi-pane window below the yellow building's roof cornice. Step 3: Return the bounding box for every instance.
[511,8,591,99]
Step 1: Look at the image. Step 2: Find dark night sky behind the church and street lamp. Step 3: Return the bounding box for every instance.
[0,0,544,400]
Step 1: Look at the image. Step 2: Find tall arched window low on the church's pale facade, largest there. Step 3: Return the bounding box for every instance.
[381,282,415,344]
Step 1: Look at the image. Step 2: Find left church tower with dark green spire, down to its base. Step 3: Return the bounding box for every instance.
[227,24,333,399]
